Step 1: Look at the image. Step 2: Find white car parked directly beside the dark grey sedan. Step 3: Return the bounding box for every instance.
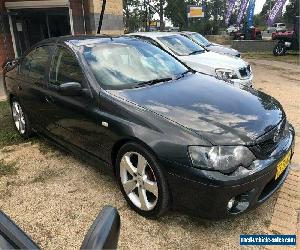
[129,32,253,87]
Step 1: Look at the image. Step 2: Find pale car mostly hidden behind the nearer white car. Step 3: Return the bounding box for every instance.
[181,31,241,57]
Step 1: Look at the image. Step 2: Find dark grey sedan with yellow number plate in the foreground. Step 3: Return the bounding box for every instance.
[4,36,295,218]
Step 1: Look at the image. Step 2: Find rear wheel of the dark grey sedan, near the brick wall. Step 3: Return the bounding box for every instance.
[11,98,32,138]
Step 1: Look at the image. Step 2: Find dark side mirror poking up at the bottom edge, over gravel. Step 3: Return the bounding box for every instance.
[80,206,121,249]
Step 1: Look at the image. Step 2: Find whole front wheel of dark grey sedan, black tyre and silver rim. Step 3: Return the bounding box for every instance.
[116,143,170,218]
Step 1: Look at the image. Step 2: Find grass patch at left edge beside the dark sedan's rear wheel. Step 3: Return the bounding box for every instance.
[0,101,24,149]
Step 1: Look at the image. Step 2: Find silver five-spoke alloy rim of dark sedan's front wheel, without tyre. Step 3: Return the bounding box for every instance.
[120,152,158,211]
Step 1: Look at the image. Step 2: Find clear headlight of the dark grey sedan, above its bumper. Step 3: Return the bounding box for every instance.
[188,146,255,174]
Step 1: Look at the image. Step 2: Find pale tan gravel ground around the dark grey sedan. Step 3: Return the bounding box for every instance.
[0,55,300,249]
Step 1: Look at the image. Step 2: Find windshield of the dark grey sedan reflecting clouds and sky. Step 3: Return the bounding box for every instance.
[83,40,188,89]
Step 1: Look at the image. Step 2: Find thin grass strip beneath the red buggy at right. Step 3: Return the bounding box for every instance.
[243,51,300,65]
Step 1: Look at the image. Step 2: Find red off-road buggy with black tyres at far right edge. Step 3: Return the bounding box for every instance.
[272,16,300,56]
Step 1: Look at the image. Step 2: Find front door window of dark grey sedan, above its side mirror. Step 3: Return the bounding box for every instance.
[50,48,84,86]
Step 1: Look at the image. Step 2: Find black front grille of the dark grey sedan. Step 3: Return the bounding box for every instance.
[251,119,287,159]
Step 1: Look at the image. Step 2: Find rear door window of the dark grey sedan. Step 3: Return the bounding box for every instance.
[21,46,52,80]
